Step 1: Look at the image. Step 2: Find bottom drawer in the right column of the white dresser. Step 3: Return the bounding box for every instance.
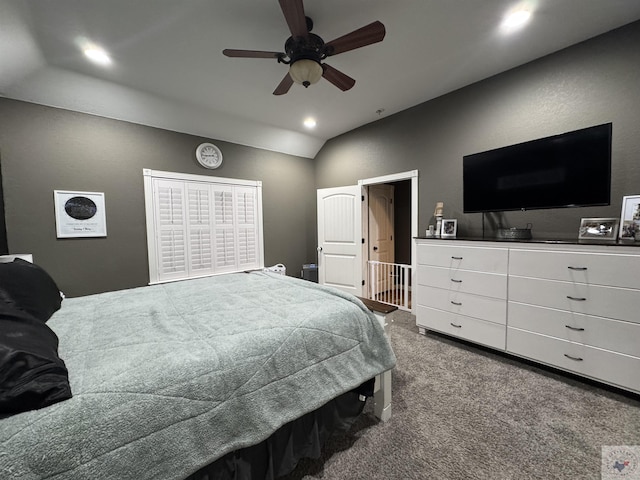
[507,327,640,392]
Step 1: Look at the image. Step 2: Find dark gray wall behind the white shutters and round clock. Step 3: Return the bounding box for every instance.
[0,98,315,296]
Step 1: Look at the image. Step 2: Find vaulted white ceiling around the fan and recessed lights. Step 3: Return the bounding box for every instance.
[0,0,640,157]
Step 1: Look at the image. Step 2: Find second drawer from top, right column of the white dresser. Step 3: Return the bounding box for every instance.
[509,276,640,323]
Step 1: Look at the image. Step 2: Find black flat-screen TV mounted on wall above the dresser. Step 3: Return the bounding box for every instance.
[462,123,612,213]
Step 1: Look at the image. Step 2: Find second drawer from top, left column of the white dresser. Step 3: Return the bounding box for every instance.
[416,265,507,299]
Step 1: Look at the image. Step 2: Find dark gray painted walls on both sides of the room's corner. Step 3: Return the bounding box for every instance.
[5,22,640,296]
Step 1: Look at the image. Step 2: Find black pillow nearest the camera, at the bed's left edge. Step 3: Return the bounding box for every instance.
[0,303,71,418]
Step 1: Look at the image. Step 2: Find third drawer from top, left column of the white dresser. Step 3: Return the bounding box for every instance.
[417,285,507,325]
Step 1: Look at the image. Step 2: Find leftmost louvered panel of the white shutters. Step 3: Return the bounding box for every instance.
[153,179,188,281]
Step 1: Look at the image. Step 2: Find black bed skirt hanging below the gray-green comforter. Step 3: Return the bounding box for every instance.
[185,380,373,480]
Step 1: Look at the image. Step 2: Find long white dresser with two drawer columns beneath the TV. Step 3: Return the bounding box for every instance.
[416,239,640,392]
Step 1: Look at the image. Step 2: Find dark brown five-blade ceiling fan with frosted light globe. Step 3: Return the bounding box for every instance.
[222,0,386,95]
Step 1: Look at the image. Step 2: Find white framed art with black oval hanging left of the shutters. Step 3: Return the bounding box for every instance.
[53,190,107,238]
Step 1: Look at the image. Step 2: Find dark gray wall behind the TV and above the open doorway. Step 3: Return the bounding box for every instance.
[316,22,640,239]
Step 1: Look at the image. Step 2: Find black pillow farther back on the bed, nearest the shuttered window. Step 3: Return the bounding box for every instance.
[0,258,62,322]
